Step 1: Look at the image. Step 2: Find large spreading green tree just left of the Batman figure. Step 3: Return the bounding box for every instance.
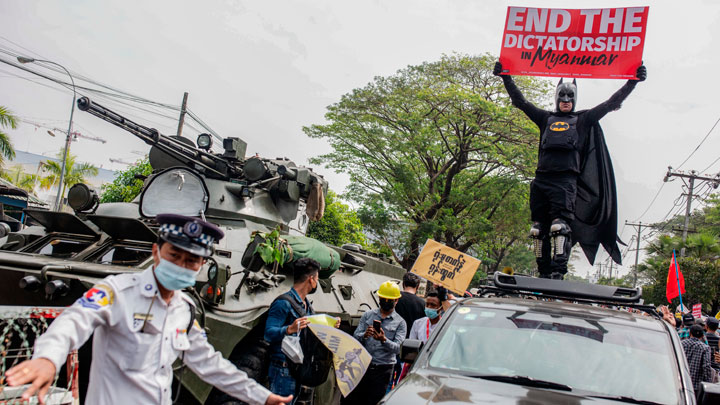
[303,55,550,267]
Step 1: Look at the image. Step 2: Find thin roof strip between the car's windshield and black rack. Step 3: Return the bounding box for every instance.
[457,297,667,332]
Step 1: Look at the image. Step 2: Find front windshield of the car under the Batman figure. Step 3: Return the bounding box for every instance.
[429,306,680,404]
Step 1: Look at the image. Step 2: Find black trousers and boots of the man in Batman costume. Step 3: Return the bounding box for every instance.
[530,172,577,275]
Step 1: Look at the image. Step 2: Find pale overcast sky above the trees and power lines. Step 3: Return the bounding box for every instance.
[0,0,720,273]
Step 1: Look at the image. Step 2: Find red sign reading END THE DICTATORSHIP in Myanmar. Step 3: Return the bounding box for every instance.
[500,7,649,79]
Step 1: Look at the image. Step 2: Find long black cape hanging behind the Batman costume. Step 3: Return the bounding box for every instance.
[570,119,625,264]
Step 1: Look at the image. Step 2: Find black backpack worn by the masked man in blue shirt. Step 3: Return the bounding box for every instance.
[276,293,333,387]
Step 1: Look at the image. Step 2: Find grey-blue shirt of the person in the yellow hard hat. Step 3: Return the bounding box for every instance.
[353,309,407,364]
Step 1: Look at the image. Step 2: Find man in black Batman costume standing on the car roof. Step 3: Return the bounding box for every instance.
[493,62,647,280]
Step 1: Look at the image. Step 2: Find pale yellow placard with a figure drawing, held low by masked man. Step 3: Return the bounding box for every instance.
[308,324,372,397]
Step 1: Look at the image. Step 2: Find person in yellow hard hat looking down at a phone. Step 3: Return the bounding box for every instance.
[341,281,407,405]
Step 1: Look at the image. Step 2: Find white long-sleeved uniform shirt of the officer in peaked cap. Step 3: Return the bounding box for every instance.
[33,269,270,405]
